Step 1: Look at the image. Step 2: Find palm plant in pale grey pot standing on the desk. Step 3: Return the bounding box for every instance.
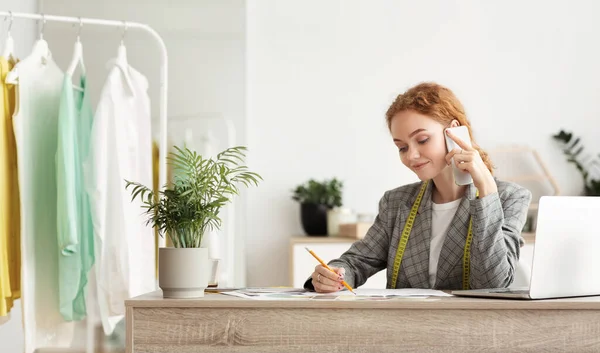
[125,146,262,298]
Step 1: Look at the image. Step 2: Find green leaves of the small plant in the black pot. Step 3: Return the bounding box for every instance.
[292,178,344,208]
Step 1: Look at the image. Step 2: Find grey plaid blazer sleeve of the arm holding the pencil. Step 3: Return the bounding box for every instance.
[304,192,394,290]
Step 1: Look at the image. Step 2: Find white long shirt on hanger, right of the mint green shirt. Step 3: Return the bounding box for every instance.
[84,51,156,334]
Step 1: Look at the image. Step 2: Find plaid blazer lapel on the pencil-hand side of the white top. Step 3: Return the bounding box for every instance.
[401,180,433,288]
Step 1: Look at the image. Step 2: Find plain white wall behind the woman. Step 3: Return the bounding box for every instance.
[247,0,600,286]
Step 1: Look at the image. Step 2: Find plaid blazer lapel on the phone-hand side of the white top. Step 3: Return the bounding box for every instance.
[435,184,476,287]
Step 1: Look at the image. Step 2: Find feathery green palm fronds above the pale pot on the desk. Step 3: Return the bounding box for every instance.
[125,146,262,248]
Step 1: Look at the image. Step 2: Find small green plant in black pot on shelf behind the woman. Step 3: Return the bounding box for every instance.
[292,178,343,235]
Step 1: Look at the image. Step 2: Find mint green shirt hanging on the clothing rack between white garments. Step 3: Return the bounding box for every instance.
[56,74,94,321]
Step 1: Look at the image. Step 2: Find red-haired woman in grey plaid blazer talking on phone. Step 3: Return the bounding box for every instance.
[305,83,531,293]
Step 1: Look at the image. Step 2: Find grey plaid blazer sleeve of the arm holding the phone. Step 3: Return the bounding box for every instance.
[470,184,531,289]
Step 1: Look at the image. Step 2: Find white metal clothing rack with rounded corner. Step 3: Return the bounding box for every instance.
[0,11,169,353]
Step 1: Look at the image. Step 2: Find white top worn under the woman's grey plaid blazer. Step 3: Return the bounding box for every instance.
[429,199,462,288]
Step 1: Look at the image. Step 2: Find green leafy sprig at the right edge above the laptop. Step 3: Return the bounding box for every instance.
[552,130,600,196]
